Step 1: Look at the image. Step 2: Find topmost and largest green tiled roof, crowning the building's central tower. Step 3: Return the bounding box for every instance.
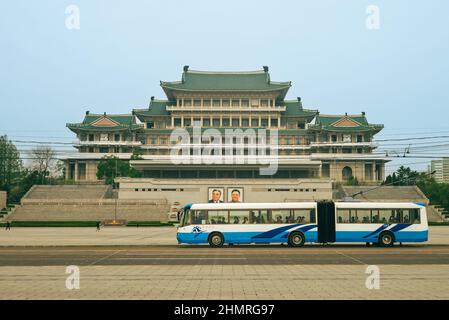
[161,69,291,99]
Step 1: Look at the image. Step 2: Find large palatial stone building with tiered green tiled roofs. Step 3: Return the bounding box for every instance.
[66,66,386,201]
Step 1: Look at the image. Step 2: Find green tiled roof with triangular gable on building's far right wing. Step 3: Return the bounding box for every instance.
[309,113,383,132]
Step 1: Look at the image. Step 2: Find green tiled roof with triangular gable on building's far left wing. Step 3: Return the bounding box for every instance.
[66,113,143,132]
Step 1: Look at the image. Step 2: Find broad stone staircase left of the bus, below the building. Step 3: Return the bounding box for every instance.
[3,184,170,222]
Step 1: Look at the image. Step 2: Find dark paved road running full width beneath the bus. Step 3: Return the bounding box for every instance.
[0,245,449,266]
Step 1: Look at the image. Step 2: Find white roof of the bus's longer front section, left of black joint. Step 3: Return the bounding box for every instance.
[190,202,316,210]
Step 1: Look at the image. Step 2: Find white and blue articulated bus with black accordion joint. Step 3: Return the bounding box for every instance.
[177,201,428,247]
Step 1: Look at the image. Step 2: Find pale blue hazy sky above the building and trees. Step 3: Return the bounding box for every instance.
[0,0,449,172]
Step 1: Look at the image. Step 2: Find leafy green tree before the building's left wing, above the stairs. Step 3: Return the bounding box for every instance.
[97,156,141,184]
